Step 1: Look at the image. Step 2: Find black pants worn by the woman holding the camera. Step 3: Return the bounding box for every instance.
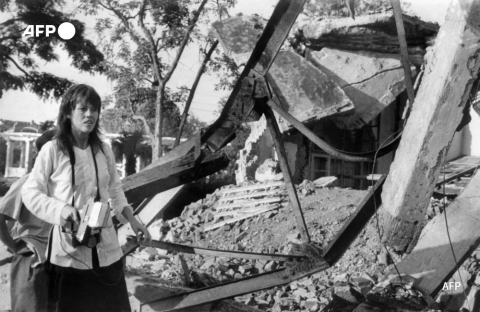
[50,248,131,312]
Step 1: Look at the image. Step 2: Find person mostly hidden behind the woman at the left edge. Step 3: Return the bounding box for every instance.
[0,130,55,312]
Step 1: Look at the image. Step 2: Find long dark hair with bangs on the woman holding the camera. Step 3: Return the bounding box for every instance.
[55,84,102,163]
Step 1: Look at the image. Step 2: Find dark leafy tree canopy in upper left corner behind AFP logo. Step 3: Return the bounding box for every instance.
[0,0,104,99]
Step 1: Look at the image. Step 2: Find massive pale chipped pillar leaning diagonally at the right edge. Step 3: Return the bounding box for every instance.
[382,0,480,252]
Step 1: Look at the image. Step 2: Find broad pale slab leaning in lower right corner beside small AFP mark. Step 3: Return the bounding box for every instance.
[397,172,480,297]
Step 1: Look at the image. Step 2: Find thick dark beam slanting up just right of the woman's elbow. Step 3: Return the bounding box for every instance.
[123,152,230,202]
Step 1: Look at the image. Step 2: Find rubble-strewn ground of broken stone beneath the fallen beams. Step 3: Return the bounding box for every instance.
[127,181,480,312]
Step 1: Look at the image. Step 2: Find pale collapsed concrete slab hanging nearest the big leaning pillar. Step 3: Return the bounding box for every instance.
[307,48,405,129]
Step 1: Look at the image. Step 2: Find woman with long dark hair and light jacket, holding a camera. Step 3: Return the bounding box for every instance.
[22,85,150,311]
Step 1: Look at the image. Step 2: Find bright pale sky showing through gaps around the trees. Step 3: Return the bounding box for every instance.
[0,0,450,127]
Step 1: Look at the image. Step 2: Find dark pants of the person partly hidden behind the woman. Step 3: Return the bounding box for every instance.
[10,242,49,312]
